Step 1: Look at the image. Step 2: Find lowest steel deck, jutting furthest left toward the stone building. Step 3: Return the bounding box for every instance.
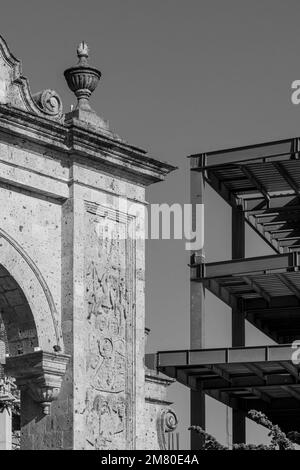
[146,345,300,431]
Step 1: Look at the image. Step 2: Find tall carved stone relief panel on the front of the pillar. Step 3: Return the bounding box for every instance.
[85,203,135,449]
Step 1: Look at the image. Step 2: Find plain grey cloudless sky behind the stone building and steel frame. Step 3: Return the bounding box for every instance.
[0,0,300,445]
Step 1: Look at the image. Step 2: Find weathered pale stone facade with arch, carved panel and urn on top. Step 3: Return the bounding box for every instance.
[0,38,176,450]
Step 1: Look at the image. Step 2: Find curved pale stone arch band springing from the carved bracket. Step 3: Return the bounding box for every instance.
[0,229,64,356]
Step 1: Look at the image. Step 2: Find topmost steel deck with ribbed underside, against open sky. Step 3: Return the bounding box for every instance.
[192,138,300,253]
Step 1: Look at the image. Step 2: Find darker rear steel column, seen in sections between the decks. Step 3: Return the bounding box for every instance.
[231,205,246,444]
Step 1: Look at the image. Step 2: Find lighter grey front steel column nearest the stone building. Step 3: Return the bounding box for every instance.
[190,156,205,450]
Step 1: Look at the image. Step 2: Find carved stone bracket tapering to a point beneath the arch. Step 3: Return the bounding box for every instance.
[5,351,69,415]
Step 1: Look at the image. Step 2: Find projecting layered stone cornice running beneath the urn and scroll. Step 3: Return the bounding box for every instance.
[0,105,176,186]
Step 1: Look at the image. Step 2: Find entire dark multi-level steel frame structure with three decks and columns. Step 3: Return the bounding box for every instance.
[146,138,300,449]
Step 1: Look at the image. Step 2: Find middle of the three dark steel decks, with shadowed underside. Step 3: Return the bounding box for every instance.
[192,252,300,343]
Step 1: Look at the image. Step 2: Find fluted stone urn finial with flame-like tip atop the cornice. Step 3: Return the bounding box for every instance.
[64,41,101,112]
